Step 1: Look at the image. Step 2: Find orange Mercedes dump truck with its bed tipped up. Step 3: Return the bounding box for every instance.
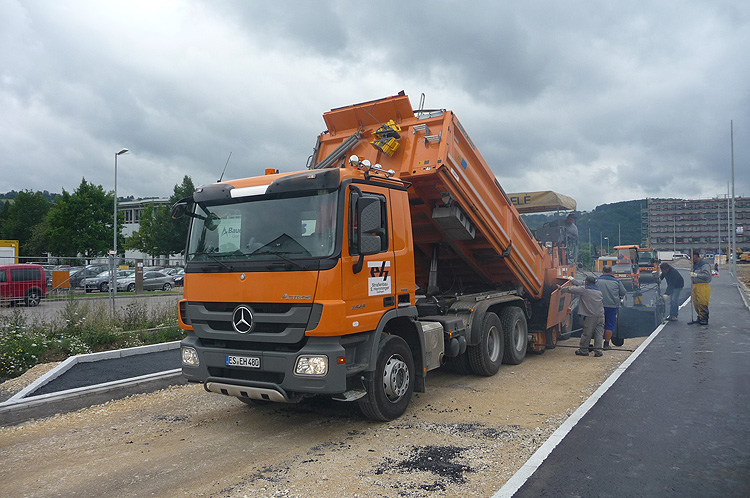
[173,94,575,420]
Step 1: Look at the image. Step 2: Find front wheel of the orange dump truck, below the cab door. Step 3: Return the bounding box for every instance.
[358,335,415,422]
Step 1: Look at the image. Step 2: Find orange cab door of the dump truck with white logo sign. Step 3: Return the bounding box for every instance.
[341,185,396,333]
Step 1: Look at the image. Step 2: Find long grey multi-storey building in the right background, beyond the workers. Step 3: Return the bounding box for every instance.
[641,196,750,254]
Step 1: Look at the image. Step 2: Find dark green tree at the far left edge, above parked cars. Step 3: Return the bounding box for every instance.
[0,190,50,256]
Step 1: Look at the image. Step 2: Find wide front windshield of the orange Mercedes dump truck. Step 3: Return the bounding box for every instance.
[187,190,338,261]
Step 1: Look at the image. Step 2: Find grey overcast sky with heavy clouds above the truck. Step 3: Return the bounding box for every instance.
[0,0,750,211]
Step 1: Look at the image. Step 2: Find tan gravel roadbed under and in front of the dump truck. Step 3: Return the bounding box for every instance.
[0,338,643,498]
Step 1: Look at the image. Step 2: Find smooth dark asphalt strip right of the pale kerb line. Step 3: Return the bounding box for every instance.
[513,272,750,498]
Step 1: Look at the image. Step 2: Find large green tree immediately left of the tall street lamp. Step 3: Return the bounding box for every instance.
[46,178,115,258]
